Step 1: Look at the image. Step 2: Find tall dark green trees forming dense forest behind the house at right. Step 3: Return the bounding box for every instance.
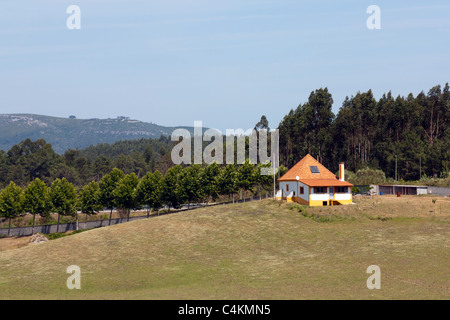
[279,83,450,181]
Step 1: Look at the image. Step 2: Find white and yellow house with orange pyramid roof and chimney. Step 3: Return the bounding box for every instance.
[276,154,353,206]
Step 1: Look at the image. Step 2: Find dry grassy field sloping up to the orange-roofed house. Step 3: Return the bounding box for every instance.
[0,196,450,299]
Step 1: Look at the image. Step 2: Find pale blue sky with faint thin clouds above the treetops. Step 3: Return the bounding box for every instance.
[0,0,450,131]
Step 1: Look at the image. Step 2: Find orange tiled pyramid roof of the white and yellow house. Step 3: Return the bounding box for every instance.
[278,154,352,186]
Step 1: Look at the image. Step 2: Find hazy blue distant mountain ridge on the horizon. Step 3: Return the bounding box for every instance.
[0,114,199,154]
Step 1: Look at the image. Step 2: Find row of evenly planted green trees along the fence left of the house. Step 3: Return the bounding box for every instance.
[0,162,273,233]
